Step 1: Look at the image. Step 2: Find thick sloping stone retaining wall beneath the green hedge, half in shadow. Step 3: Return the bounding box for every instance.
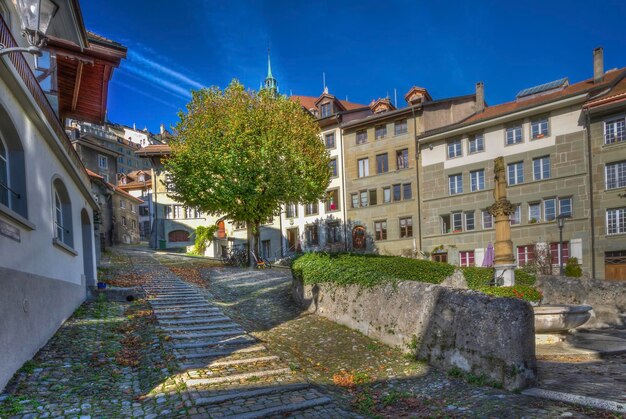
[292,278,536,390]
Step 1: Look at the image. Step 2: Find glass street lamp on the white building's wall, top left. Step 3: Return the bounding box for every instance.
[0,0,59,56]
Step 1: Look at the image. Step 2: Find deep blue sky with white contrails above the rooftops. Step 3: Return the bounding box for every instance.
[81,0,626,132]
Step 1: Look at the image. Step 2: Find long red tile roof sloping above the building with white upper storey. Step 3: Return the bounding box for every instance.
[462,69,625,125]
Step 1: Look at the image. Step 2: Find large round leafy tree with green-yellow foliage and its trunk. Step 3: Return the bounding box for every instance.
[165,80,330,264]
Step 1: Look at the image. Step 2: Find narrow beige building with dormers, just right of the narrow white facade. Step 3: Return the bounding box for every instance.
[343,87,476,255]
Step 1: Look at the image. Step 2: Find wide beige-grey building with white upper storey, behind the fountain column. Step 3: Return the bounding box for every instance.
[418,50,623,274]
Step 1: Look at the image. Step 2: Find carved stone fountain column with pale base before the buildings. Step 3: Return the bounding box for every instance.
[487,157,515,286]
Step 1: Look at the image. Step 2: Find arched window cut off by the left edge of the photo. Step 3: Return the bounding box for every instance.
[0,106,28,218]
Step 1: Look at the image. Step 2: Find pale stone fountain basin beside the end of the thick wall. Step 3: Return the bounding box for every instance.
[533,304,591,333]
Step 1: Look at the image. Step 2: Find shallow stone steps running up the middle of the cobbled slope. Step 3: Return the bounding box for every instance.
[144,258,360,419]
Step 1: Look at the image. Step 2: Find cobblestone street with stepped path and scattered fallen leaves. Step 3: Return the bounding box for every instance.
[0,248,624,418]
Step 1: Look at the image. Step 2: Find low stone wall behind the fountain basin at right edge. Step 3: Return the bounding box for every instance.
[536,276,626,327]
